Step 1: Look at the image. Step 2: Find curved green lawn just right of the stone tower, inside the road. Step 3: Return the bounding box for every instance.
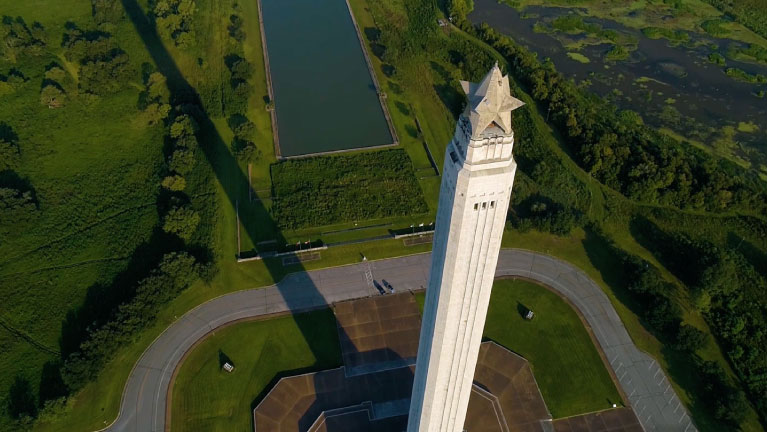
[416,279,621,418]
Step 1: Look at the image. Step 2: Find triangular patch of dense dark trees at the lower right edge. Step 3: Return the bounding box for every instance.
[634,218,767,421]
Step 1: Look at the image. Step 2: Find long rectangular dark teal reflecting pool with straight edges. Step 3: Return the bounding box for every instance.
[261,0,393,156]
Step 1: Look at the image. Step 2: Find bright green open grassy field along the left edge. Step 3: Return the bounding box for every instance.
[0,1,164,430]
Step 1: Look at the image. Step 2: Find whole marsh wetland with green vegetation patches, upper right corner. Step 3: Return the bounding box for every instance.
[468,0,767,174]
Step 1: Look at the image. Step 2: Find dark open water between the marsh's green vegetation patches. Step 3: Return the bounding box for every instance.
[469,0,767,163]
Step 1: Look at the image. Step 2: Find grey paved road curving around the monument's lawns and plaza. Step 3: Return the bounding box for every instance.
[102,249,695,432]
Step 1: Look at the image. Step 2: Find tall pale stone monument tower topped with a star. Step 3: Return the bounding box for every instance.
[407,63,523,432]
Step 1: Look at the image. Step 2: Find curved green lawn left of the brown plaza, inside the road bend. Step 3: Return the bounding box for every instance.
[171,309,341,432]
